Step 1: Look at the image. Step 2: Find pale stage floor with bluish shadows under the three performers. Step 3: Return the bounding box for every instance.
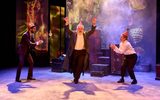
[0,67,160,100]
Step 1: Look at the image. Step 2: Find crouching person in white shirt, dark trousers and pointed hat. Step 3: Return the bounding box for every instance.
[110,29,137,84]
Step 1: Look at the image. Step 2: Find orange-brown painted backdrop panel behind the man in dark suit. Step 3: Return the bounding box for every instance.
[16,0,48,52]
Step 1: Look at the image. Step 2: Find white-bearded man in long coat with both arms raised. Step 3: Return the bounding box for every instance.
[64,17,96,84]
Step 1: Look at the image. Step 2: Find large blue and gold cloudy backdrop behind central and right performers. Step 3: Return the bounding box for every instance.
[66,0,157,71]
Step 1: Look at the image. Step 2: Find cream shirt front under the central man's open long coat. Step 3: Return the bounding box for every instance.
[74,34,84,50]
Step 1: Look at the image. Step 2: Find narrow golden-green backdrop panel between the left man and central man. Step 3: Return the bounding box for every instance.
[49,5,65,61]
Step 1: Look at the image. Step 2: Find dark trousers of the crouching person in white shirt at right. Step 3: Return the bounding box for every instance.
[121,54,137,79]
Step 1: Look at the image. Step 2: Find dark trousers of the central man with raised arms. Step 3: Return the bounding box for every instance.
[70,50,86,81]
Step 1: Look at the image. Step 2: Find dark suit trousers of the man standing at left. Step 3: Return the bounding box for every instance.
[16,53,33,80]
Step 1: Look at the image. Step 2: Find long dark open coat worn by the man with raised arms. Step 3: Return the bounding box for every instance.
[63,25,96,72]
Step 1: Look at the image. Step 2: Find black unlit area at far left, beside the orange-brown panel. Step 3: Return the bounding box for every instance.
[0,0,17,68]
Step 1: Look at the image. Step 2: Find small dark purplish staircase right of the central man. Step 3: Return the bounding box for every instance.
[90,48,111,77]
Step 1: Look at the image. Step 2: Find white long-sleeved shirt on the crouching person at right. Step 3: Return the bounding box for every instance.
[114,40,136,55]
